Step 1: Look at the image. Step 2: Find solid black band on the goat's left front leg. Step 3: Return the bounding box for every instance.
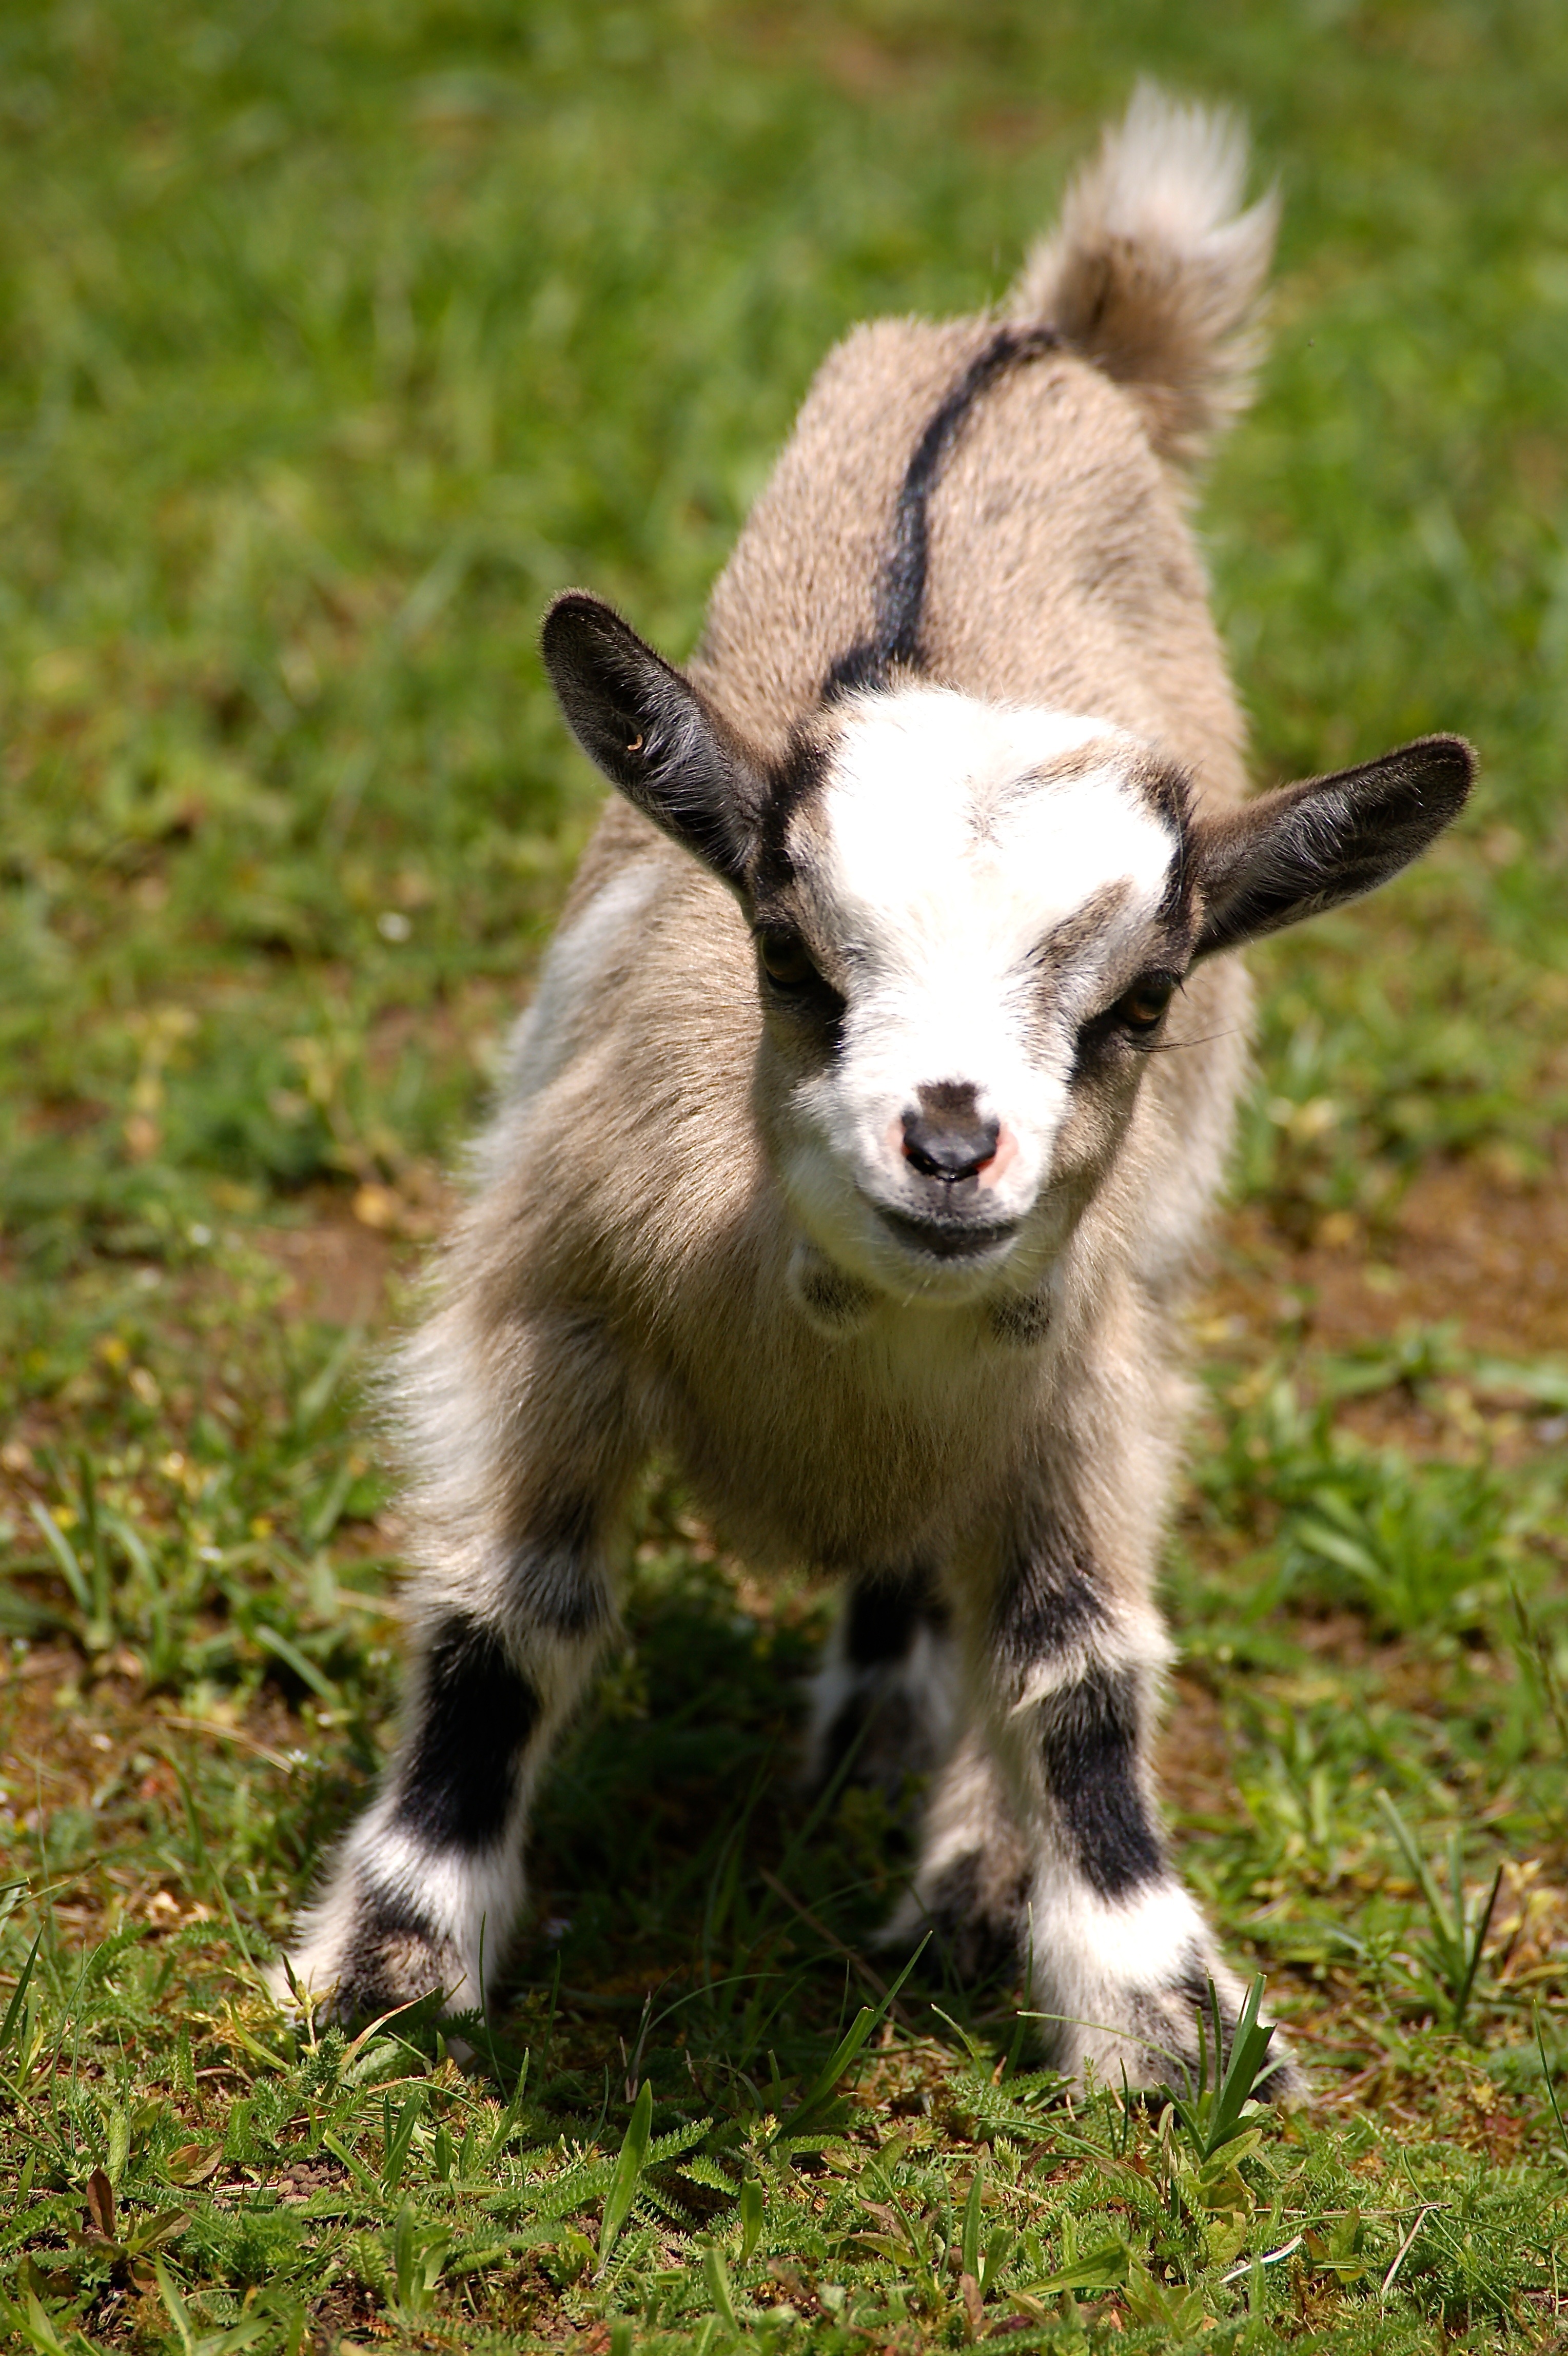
[396,1616,539,1850]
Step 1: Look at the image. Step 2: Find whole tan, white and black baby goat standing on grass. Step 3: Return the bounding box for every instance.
[278,89,1472,2092]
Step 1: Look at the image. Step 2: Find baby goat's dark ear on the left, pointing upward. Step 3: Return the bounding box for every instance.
[541,589,765,886]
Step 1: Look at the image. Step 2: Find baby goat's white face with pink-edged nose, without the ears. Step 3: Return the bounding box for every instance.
[756,688,1189,1301]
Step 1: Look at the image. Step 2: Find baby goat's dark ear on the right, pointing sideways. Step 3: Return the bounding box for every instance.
[1193,737,1476,956]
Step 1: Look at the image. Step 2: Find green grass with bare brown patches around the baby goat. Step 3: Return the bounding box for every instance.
[0,0,1568,2356]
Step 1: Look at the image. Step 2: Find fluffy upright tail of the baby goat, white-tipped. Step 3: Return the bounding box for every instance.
[1008,83,1279,464]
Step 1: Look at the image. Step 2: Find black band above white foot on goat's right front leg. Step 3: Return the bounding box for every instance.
[1041,1668,1165,1899]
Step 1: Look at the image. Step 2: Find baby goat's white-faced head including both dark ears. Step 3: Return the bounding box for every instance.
[544,592,1472,1301]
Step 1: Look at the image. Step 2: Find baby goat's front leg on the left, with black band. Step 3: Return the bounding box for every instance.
[276,1310,633,2019]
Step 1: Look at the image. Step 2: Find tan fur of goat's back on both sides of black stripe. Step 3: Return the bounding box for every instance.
[692,316,1243,801]
